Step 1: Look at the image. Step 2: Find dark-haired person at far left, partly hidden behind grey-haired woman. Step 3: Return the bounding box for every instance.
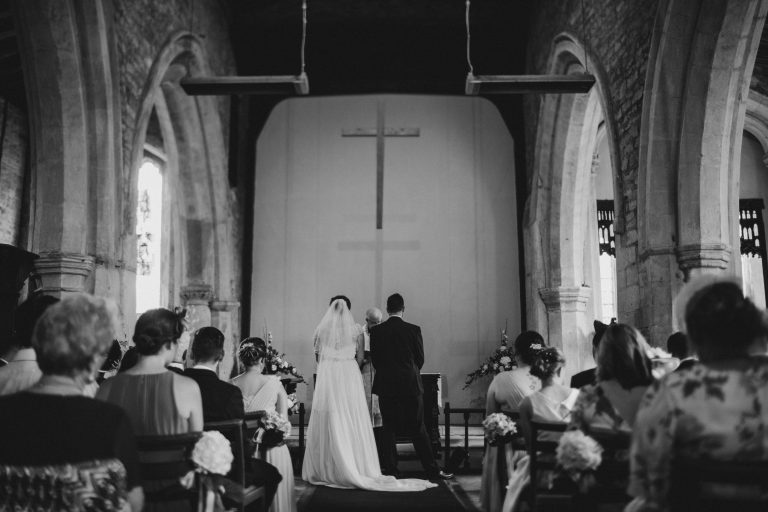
[0,295,59,395]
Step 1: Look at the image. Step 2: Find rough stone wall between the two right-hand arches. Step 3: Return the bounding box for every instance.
[524,0,658,329]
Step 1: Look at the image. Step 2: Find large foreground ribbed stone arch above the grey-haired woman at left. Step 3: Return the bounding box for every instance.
[13,0,124,303]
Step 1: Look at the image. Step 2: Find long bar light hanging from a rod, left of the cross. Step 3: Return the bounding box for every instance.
[181,0,309,96]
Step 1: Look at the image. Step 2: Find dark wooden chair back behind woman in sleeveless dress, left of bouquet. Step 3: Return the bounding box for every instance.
[136,432,201,504]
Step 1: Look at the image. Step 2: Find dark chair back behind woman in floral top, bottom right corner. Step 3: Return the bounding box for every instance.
[669,458,768,512]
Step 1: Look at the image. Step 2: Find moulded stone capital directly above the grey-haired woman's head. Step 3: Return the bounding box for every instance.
[35,252,95,298]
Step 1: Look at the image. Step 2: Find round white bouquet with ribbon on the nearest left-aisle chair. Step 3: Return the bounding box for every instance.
[181,430,235,512]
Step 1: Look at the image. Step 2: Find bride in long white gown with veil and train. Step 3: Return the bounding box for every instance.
[301,299,436,491]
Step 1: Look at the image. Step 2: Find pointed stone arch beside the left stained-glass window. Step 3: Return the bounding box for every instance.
[129,32,239,377]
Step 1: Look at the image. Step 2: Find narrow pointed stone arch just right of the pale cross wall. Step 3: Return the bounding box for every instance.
[524,34,622,375]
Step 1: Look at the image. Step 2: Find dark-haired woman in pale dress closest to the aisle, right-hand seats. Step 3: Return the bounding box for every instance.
[480,331,546,512]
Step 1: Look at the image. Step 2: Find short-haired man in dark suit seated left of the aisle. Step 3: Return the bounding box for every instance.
[184,327,245,422]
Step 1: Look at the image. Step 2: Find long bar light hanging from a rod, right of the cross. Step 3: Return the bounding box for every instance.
[464,0,595,96]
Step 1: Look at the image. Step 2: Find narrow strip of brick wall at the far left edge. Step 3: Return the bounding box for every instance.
[0,98,28,245]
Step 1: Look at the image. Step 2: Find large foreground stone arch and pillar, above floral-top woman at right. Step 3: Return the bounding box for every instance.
[637,0,768,344]
